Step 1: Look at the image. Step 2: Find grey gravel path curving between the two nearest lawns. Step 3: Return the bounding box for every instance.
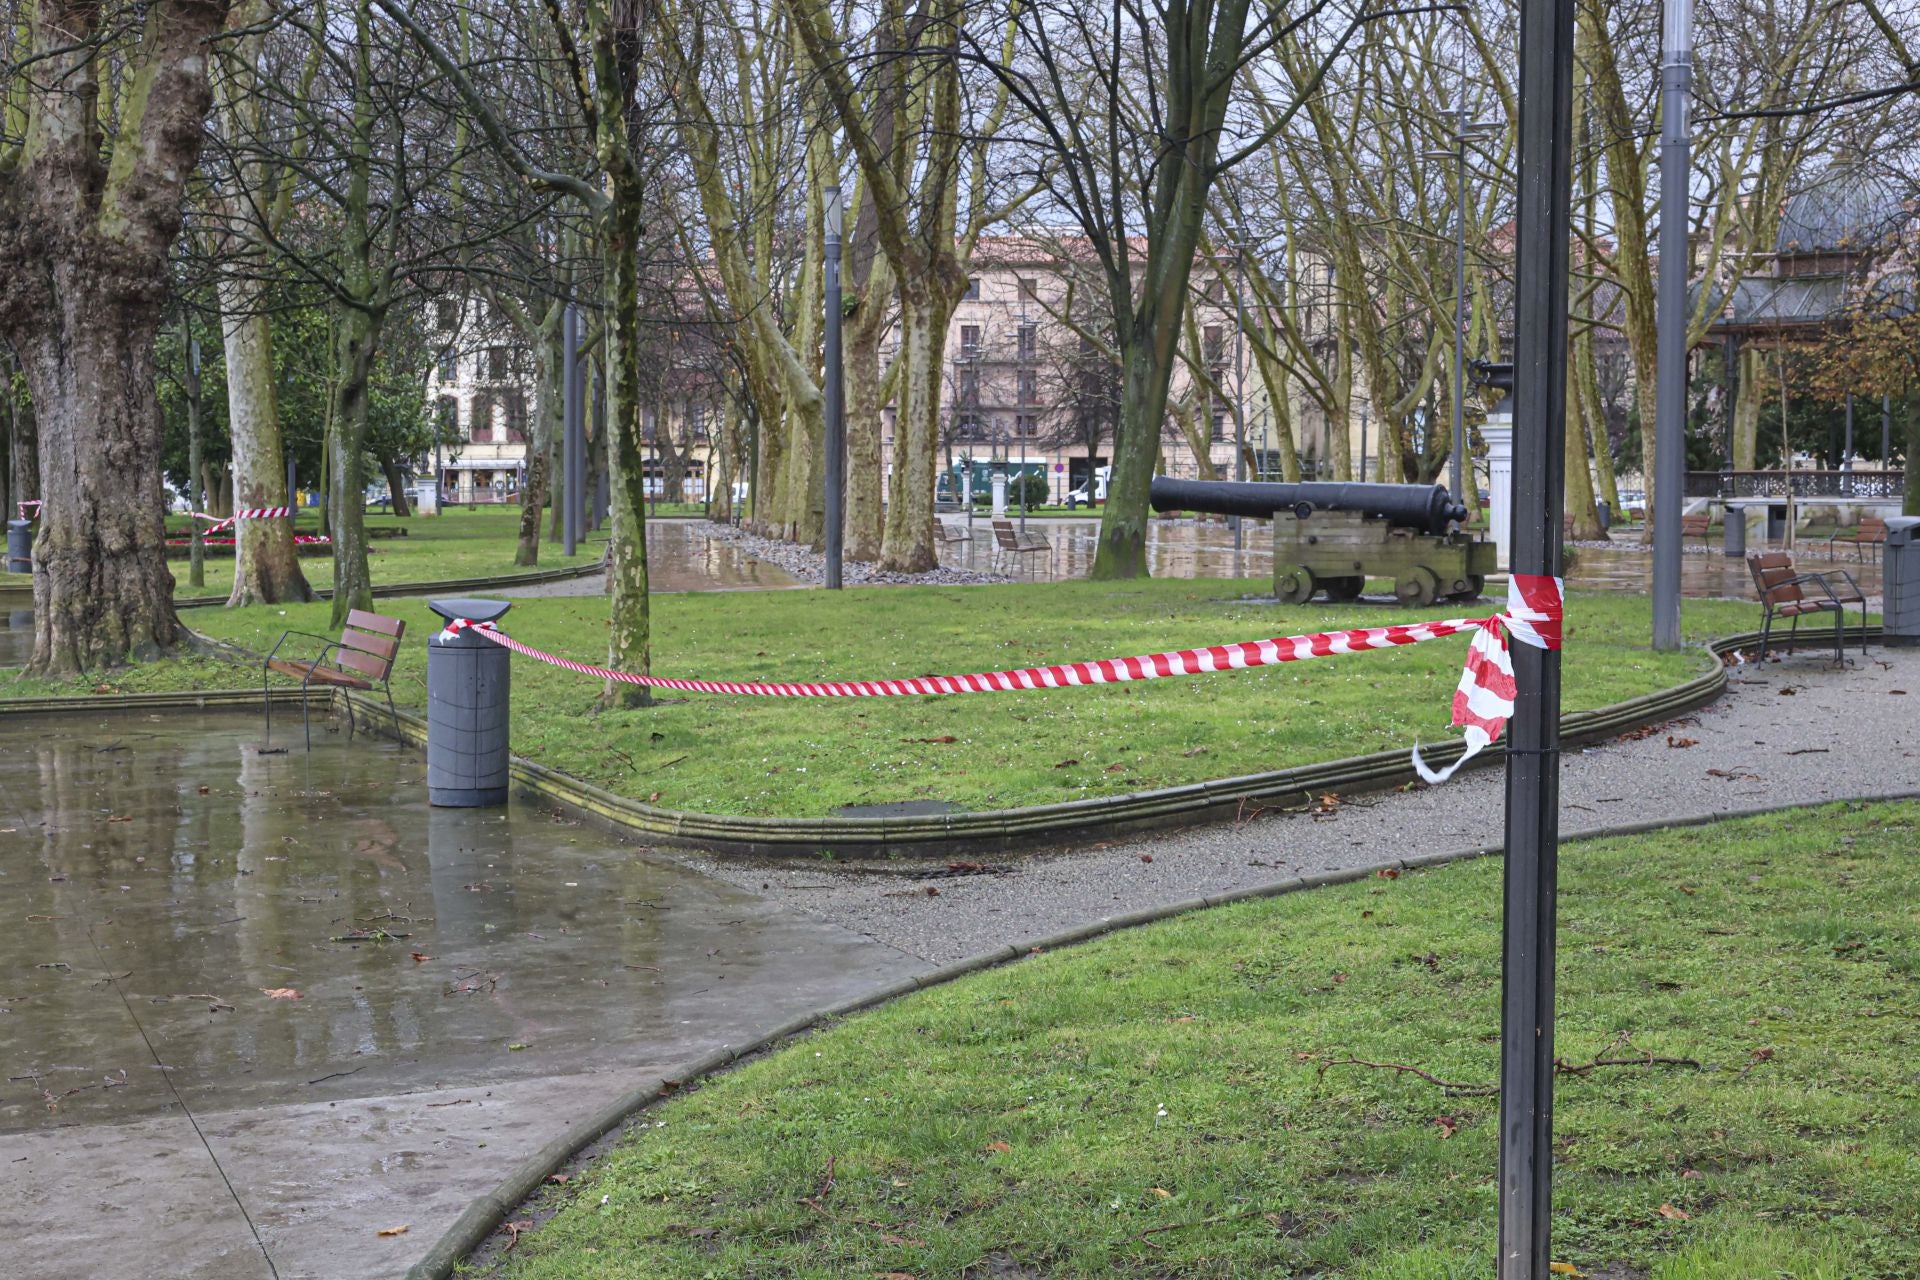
[687,647,1920,963]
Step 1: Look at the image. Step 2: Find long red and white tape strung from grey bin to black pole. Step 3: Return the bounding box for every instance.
[438,574,1563,783]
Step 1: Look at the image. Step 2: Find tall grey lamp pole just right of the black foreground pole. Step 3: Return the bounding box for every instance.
[1653,0,1693,649]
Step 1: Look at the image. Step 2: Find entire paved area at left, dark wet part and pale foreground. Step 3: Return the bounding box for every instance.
[0,716,927,1280]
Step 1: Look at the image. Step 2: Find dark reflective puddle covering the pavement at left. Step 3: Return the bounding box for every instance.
[0,716,898,1132]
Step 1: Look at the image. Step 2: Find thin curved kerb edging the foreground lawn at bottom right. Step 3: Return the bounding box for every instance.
[407,791,1920,1280]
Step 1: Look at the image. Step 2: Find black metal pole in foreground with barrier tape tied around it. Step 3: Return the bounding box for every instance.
[1496,0,1574,1280]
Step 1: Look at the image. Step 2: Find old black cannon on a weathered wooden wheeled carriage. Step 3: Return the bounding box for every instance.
[1150,476,1500,606]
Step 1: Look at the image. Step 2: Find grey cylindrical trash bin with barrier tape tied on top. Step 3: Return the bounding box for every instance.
[426,601,513,808]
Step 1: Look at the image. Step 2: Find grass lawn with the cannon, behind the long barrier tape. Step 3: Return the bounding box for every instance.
[0,580,1755,818]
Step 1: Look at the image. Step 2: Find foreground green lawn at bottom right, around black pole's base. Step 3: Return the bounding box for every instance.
[480,804,1920,1280]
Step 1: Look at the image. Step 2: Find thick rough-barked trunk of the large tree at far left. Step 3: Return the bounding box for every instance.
[10,307,186,677]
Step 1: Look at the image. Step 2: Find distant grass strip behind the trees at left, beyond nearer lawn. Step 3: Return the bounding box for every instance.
[167,507,607,599]
